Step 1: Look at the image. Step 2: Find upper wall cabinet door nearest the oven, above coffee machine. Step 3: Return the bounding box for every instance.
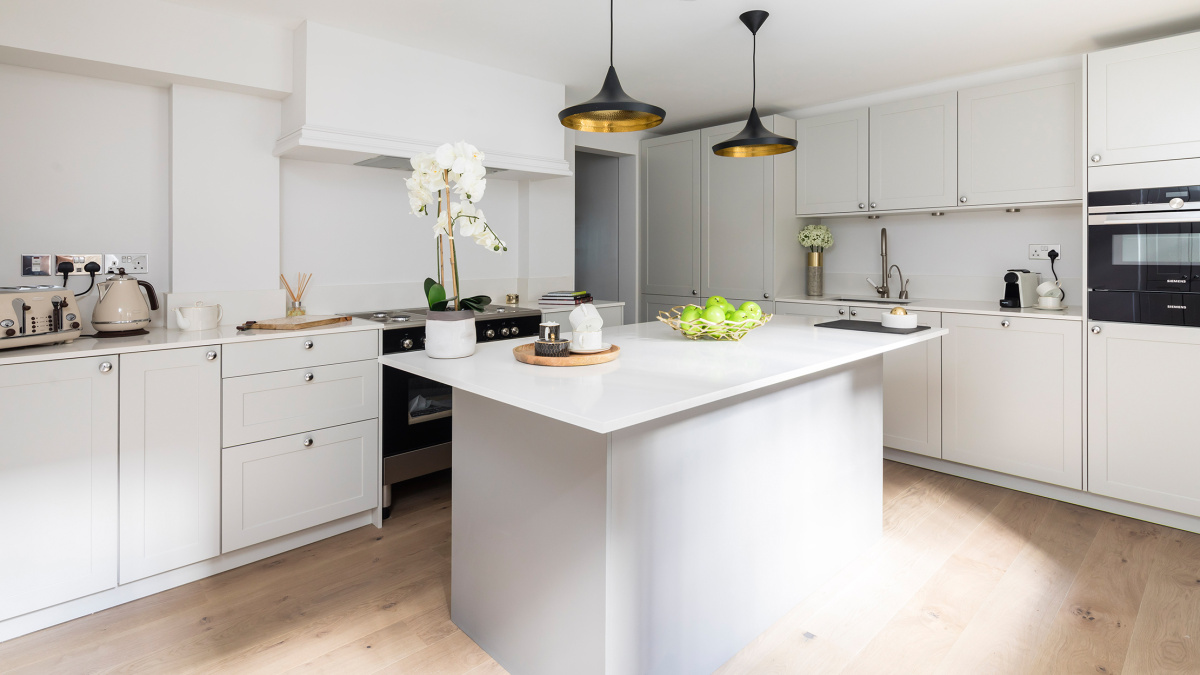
[959,70,1084,205]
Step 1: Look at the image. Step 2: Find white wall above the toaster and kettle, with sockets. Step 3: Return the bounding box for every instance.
[0,63,170,319]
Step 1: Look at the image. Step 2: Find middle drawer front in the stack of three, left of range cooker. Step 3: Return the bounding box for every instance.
[221,360,379,448]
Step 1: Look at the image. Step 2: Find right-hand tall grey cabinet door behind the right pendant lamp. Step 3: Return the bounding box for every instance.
[700,118,775,301]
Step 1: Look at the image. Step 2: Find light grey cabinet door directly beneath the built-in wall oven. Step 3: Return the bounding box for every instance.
[1087,323,1200,515]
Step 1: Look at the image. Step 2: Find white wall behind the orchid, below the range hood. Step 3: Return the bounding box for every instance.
[281,160,523,312]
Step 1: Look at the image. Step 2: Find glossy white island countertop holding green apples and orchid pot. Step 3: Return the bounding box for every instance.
[379,315,948,434]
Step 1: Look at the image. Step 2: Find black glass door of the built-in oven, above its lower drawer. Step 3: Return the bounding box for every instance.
[1087,216,1200,293]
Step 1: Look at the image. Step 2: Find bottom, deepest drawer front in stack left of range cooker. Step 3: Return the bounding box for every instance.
[221,419,379,552]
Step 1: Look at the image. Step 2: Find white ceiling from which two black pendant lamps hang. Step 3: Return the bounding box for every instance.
[173,0,1200,131]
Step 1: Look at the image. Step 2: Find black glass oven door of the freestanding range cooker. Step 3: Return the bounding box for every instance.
[383,368,454,456]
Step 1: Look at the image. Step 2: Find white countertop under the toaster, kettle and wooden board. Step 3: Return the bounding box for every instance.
[0,318,383,365]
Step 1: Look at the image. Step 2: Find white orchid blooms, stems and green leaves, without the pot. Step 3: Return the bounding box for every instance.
[404,141,509,311]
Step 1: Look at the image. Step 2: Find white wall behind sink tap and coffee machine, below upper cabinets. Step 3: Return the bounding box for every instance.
[811,207,1084,304]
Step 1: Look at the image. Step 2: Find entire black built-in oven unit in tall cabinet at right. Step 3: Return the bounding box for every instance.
[1087,185,1200,327]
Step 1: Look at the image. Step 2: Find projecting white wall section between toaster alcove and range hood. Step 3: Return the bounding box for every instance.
[170,85,280,294]
